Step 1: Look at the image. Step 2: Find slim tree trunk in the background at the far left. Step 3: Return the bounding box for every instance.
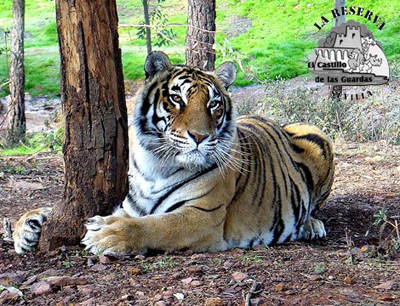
[8,0,26,144]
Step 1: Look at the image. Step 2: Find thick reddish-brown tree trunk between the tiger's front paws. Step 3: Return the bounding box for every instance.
[40,0,128,251]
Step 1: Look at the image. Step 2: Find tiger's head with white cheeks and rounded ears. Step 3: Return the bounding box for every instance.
[134,52,236,169]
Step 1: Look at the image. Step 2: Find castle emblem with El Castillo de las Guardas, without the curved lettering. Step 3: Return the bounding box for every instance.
[308,20,389,86]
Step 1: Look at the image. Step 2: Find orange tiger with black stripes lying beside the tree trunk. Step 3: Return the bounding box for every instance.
[13,51,334,254]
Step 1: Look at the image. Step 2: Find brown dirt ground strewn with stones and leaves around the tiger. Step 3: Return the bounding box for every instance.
[0,142,400,306]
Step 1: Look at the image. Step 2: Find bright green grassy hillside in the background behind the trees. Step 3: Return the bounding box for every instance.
[0,0,400,96]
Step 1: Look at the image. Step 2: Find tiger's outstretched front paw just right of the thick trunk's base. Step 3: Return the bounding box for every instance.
[81,216,138,254]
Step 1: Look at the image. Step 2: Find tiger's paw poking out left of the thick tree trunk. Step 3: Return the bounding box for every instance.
[12,207,51,254]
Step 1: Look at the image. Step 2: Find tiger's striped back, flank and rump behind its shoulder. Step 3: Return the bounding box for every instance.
[225,116,334,247]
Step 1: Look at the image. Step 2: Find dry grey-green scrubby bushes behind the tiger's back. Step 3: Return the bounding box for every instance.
[259,74,400,144]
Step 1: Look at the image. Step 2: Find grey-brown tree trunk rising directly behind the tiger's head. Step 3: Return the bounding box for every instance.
[186,0,216,70]
